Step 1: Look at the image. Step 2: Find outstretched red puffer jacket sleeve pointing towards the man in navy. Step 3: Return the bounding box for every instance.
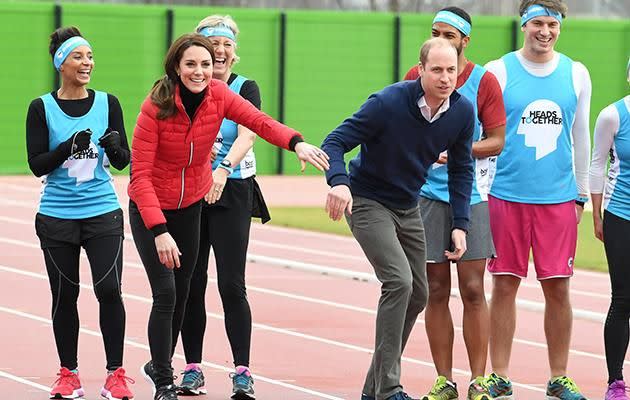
[212,79,302,150]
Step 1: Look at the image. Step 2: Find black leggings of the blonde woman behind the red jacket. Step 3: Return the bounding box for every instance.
[182,186,252,366]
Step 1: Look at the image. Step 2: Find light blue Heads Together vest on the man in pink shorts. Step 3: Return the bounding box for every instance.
[490,52,578,204]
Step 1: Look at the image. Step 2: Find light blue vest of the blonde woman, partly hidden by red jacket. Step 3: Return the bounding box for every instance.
[212,75,256,179]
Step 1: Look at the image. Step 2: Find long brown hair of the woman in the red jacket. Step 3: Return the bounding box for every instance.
[149,33,214,119]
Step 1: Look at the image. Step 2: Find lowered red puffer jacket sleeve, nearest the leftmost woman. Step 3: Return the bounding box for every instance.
[128,97,166,229]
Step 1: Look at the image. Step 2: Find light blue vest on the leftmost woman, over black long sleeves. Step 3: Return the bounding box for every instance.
[39,92,120,219]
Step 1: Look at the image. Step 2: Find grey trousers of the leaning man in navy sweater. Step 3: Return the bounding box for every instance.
[347,196,428,400]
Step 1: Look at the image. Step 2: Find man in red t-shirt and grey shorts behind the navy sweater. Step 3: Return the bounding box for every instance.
[405,7,505,400]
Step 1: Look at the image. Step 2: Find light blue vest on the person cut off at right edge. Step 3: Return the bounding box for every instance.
[604,99,630,220]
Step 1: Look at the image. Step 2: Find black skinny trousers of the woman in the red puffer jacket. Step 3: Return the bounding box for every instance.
[129,202,201,386]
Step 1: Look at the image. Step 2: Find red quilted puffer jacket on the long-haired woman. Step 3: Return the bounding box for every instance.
[128,79,300,229]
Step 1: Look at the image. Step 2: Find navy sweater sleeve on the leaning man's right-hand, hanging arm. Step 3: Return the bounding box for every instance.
[447,102,475,231]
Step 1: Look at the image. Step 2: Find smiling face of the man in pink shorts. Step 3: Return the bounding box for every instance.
[521,16,560,62]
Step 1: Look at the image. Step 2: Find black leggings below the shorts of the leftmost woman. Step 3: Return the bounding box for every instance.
[43,236,125,371]
